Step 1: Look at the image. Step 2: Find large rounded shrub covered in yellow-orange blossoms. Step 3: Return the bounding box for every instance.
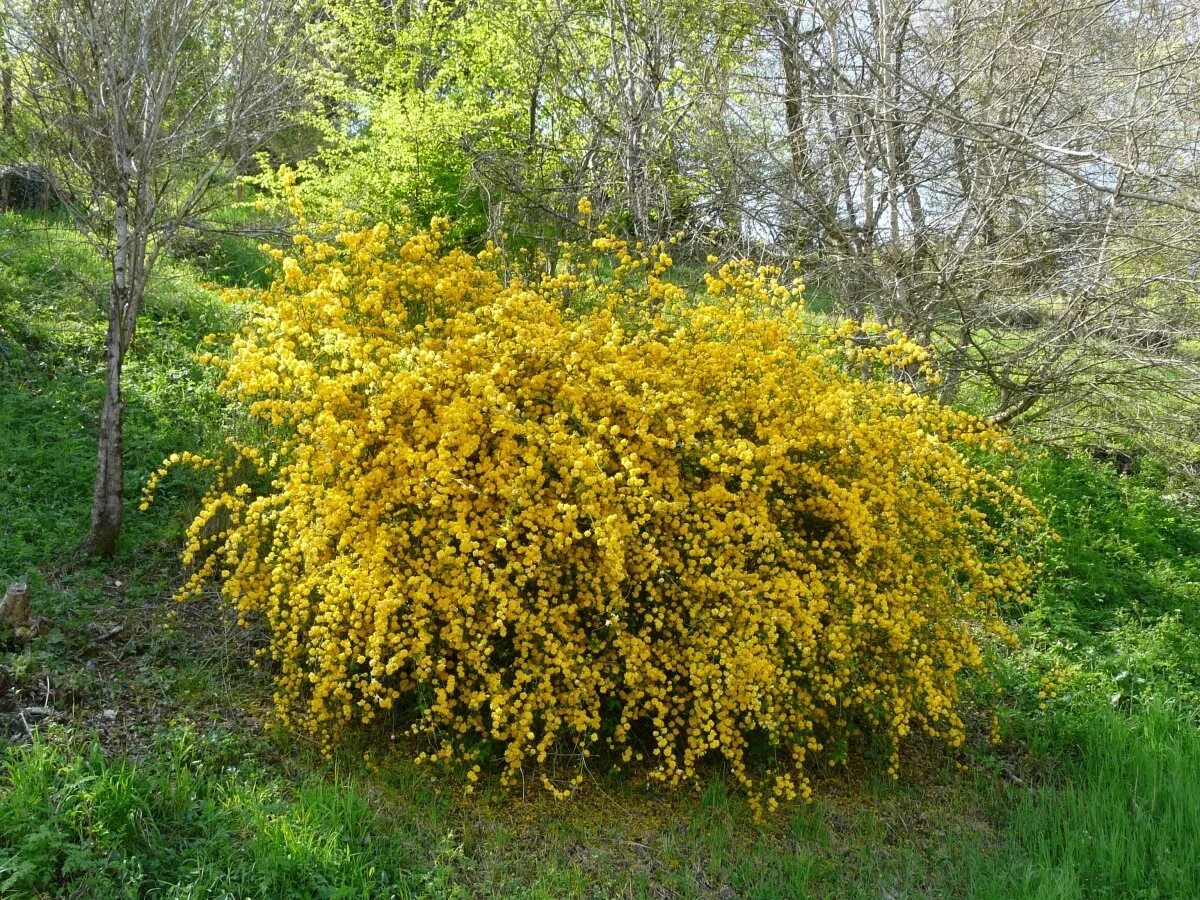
[151,218,1030,804]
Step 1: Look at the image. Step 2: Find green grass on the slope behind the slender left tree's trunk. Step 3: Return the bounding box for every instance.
[0,214,229,577]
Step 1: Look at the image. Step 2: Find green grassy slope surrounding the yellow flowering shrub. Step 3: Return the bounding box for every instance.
[0,217,1200,898]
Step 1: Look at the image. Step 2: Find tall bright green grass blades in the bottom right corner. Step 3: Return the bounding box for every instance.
[971,702,1200,898]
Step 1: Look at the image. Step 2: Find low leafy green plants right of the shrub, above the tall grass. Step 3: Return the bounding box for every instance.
[1018,451,1200,722]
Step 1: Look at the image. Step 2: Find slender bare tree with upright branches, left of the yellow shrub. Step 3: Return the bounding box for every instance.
[4,0,305,556]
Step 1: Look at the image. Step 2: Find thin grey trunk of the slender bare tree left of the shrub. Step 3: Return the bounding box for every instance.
[86,303,126,557]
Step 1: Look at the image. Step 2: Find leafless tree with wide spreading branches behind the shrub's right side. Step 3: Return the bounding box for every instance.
[755,0,1200,453]
